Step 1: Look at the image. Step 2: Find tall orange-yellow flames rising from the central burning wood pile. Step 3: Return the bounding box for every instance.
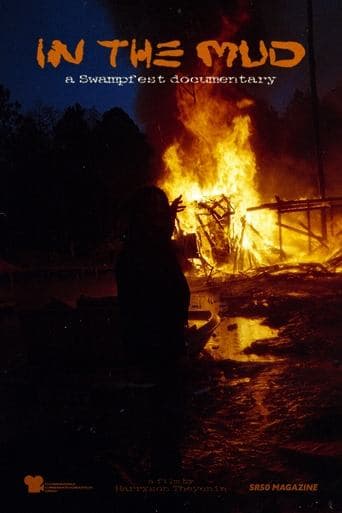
[160,86,279,270]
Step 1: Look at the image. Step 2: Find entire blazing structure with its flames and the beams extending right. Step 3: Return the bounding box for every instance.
[160,65,342,275]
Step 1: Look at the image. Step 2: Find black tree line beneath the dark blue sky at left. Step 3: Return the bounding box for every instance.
[0,86,151,255]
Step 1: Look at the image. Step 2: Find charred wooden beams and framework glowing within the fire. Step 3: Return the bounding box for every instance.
[175,194,342,276]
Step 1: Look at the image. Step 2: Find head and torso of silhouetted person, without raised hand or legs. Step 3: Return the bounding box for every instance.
[116,187,190,363]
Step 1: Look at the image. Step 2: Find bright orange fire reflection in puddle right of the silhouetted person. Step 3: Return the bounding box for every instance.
[205,317,280,362]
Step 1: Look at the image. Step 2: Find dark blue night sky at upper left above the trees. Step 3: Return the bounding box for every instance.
[0,0,136,114]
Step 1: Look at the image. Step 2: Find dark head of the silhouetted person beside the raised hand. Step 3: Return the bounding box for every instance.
[120,186,172,242]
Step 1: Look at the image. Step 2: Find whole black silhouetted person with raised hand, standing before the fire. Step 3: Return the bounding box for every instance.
[116,187,190,477]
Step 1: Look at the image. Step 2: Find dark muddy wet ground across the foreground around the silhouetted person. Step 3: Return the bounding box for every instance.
[0,273,342,513]
